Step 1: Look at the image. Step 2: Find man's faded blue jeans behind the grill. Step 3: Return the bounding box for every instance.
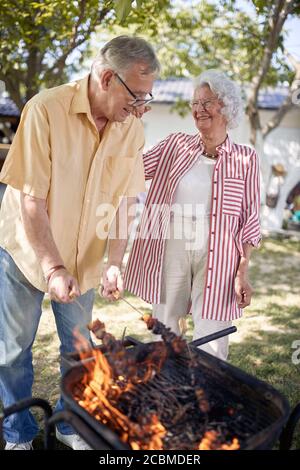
[0,247,94,443]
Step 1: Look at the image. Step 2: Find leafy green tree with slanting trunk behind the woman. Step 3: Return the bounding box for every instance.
[99,0,300,145]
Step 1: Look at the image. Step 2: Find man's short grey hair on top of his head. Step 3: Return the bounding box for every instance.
[92,35,160,79]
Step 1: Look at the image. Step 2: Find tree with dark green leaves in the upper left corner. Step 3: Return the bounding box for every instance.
[0,0,168,110]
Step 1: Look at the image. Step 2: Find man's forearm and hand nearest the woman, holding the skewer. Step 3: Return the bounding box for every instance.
[101,197,136,300]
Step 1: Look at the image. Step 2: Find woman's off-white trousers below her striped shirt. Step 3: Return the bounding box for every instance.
[153,217,232,360]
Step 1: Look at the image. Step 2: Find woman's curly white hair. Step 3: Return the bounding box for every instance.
[194,69,243,129]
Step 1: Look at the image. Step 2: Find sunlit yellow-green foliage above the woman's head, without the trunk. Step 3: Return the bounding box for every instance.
[98,0,291,85]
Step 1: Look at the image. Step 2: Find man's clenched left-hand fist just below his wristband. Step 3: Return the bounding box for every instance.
[48,269,81,304]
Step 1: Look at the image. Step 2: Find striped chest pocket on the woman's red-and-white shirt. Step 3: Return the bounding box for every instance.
[222,178,245,217]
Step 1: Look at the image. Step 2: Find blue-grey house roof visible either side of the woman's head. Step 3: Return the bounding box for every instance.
[153,78,288,109]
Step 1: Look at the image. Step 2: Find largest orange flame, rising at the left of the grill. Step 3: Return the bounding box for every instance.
[74,324,167,450]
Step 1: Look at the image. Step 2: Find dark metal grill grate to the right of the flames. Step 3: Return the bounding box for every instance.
[116,361,280,447]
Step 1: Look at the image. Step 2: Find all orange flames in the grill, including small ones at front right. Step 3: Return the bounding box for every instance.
[73,317,240,450]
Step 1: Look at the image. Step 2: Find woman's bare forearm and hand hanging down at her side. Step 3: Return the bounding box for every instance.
[235,243,253,308]
